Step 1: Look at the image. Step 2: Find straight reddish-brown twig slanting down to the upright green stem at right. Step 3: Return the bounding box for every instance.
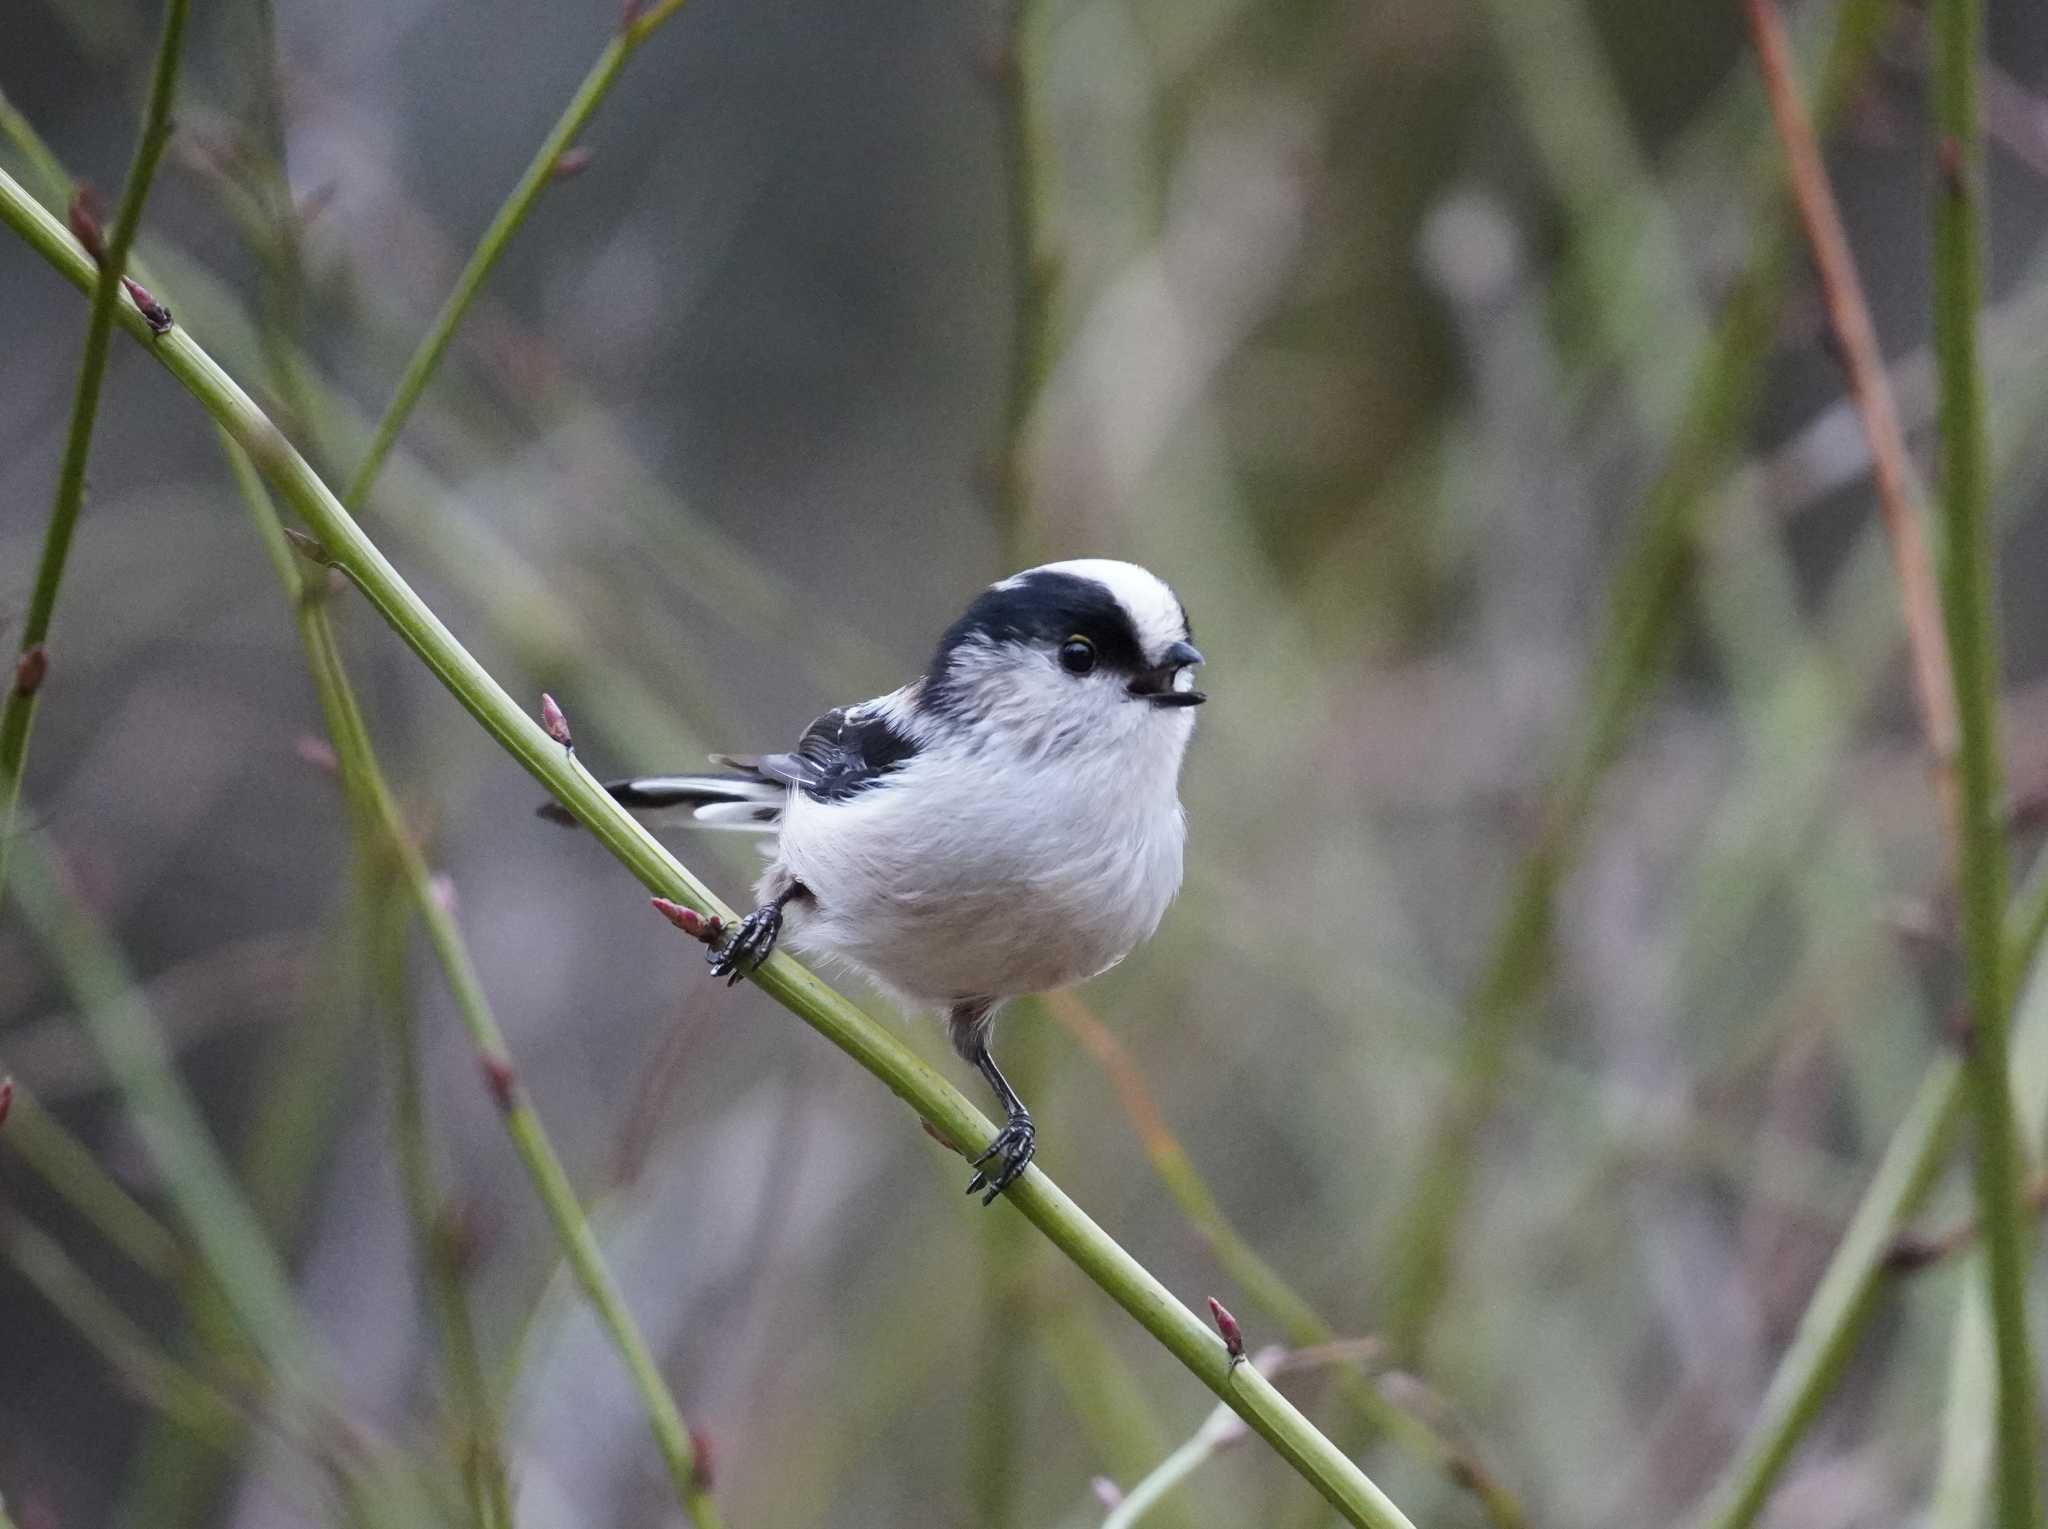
[1743,0,1960,843]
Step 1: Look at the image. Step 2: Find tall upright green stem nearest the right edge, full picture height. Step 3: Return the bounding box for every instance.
[1931,0,2040,1529]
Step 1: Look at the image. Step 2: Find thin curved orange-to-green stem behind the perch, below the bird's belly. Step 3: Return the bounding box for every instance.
[1040,993,1528,1529]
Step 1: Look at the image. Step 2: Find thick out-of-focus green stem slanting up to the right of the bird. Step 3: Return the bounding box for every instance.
[1384,0,1890,1363]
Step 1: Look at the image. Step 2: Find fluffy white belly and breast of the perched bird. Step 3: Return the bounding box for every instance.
[764,766,1184,1003]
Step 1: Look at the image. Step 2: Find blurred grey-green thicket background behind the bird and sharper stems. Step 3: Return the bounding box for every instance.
[0,0,2048,1529]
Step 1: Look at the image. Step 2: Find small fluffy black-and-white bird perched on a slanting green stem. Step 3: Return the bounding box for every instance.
[541,559,1206,1206]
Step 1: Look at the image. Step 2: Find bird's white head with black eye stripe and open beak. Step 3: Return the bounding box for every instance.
[920,557,1206,763]
